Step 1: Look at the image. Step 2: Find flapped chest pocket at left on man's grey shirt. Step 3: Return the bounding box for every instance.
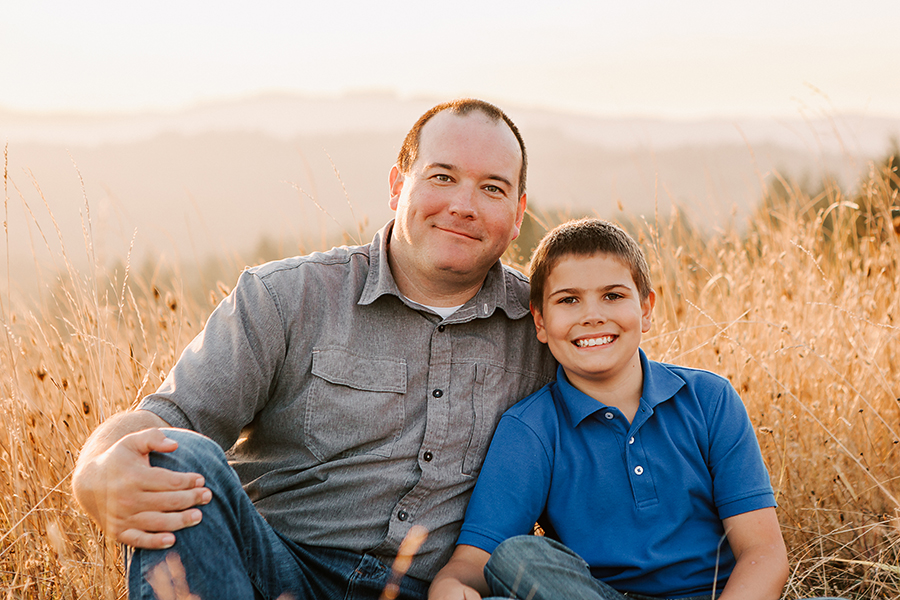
[303,348,407,461]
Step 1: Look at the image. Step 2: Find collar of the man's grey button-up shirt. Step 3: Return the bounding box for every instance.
[359,219,528,322]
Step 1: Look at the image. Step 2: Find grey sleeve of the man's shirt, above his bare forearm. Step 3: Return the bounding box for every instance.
[138,271,286,450]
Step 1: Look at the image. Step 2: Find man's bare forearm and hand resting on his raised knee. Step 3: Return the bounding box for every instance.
[72,410,212,549]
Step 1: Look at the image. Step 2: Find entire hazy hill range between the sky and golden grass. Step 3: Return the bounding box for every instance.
[0,94,900,298]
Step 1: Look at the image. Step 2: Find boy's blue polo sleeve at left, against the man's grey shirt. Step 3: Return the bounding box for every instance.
[457,414,553,553]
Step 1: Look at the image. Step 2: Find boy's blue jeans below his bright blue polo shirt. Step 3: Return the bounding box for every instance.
[484,535,841,600]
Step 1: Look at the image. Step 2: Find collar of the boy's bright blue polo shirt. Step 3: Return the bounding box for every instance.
[554,349,684,426]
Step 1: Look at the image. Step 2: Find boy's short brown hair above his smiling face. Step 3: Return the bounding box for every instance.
[529,219,652,312]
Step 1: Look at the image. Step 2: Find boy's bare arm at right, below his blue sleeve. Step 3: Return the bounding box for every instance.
[719,508,789,600]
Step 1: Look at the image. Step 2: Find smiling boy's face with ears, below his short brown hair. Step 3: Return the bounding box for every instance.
[532,254,656,391]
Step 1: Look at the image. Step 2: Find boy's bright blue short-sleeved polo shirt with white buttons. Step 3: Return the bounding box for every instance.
[457,350,775,598]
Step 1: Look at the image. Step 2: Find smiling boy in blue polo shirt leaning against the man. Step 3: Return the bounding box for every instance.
[429,219,788,600]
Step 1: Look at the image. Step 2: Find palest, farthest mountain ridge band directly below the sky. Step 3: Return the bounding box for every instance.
[0,93,900,155]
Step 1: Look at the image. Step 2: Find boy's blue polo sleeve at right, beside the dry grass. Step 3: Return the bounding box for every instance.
[709,382,776,519]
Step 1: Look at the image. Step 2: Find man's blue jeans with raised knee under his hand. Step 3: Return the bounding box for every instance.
[126,429,428,600]
